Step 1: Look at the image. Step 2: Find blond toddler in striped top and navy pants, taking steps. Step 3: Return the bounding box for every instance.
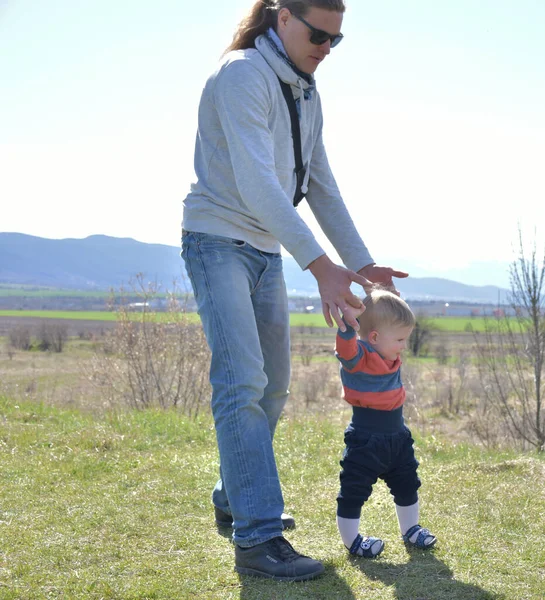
[335,289,437,558]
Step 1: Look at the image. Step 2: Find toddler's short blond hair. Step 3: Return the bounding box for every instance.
[358,287,416,334]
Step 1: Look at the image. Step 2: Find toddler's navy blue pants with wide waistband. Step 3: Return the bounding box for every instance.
[337,407,421,519]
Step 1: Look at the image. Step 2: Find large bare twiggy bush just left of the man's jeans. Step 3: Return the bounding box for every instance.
[86,276,210,416]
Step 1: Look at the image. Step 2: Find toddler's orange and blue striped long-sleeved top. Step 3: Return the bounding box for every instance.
[335,325,405,411]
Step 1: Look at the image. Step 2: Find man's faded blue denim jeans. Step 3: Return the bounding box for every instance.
[182,232,290,547]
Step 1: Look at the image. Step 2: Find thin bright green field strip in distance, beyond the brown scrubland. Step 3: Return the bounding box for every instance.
[0,310,502,333]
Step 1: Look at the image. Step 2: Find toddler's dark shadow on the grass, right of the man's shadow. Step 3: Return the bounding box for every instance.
[350,549,504,600]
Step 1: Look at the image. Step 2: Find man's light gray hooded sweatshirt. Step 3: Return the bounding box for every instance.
[182,30,373,271]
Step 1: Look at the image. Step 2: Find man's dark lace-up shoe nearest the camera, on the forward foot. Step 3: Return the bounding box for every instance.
[235,537,324,581]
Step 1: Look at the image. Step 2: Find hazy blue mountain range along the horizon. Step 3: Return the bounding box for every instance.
[0,233,508,304]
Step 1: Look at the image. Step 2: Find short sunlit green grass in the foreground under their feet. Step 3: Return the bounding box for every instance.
[0,398,545,600]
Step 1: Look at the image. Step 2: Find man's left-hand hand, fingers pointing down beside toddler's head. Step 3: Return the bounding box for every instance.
[308,254,372,331]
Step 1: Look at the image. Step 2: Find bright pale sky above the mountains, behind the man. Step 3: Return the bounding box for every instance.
[0,0,545,284]
